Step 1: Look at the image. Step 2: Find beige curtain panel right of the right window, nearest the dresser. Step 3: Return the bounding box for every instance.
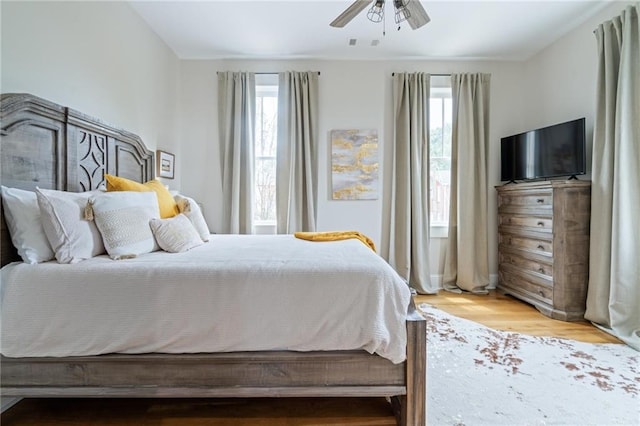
[443,74,491,293]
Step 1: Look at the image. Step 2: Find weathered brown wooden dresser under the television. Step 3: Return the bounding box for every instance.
[496,180,591,321]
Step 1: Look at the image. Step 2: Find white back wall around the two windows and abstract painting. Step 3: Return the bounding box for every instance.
[180,60,523,282]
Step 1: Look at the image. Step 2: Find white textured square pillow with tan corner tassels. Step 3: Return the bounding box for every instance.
[87,191,160,259]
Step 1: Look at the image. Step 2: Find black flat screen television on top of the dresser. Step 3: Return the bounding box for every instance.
[500,118,586,181]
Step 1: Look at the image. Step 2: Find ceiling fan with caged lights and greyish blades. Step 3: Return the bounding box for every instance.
[329,0,431,30]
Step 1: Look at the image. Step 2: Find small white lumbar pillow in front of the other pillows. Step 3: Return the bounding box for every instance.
[149,213,204,253]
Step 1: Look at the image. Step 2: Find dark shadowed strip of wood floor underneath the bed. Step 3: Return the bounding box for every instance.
[2,398,396,426]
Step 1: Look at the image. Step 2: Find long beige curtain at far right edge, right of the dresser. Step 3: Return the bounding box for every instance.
[585,6,640,350]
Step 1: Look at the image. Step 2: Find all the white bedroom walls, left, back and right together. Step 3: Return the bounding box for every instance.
[0,1,630,286]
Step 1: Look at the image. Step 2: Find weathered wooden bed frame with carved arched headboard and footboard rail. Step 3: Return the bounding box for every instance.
[0,94,426,426]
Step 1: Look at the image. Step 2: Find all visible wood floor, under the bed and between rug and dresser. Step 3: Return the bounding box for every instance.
[0,292,620,426]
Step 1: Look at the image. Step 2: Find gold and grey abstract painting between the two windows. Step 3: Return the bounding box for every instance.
[331,130,378,200]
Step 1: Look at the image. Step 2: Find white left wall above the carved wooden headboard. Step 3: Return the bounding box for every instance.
[0,1,180,186]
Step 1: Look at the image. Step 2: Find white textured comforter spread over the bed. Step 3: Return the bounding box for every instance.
[0,235,411,363]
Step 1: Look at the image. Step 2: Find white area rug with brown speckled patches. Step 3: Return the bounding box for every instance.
[419,303,640,426]
